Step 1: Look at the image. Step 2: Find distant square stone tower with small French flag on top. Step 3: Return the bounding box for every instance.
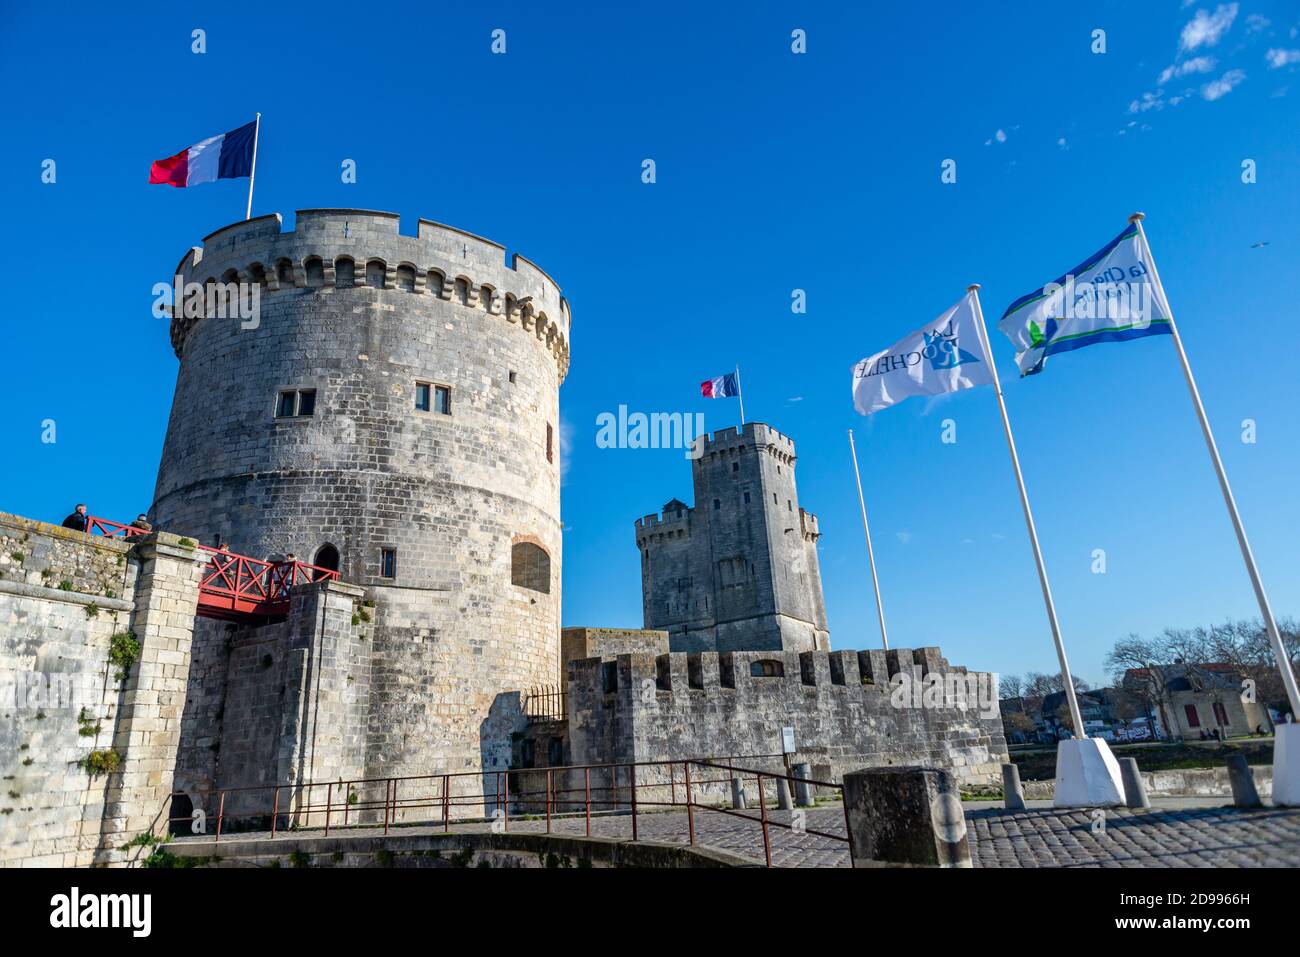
[636,423,829,651]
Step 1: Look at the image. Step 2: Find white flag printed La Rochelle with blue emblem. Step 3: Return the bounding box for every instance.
[853,293,993,415]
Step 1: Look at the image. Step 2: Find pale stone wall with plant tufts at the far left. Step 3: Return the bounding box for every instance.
[0,514,203,866]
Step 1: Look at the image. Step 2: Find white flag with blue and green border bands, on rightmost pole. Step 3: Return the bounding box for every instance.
[997,224,1170,376]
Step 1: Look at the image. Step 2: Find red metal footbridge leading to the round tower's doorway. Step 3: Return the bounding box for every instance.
[86,516,338,623]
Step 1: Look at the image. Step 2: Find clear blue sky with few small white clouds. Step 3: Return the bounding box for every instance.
[0,0,1300,683]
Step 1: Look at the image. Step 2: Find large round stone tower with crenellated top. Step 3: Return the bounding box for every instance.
[152,209,569,775]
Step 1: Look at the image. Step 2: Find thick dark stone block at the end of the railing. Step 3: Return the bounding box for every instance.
[844,767,971,867]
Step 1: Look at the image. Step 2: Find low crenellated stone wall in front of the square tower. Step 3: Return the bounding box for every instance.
[568,648,1008,784]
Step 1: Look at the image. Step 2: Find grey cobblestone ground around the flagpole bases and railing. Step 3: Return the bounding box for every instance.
[195,804,1300,867]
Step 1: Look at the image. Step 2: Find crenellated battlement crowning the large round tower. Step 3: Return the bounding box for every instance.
[170,209,572,381]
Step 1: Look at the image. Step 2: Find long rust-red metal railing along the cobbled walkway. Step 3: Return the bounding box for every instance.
[160,755,853,867]
